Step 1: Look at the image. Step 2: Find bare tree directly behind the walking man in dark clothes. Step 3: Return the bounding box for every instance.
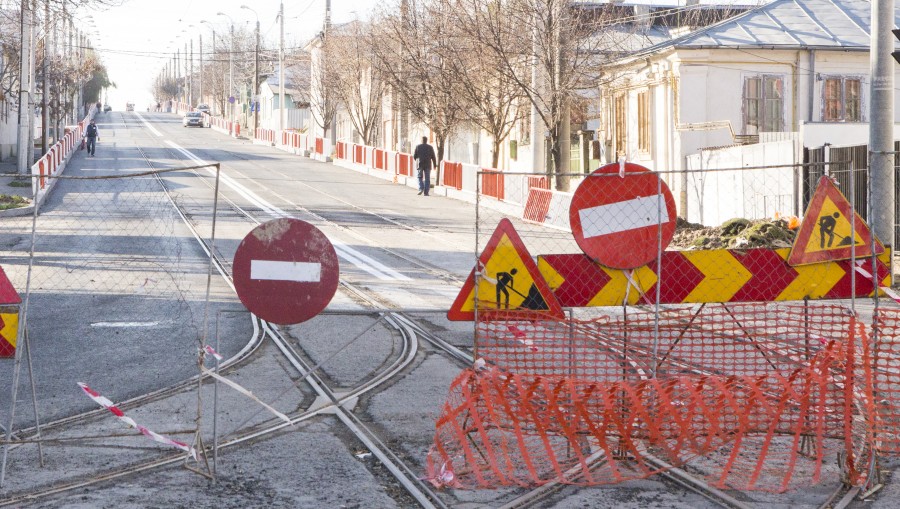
[372,0,465,182]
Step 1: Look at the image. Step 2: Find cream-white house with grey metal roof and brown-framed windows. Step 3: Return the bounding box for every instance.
[600,0,900,224]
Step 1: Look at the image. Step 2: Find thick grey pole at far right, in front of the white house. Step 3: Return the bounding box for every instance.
[868,0,895,246]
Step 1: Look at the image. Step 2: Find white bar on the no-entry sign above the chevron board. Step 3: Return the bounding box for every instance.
[578,194,669,239]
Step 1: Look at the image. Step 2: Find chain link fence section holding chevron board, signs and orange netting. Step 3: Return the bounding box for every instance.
[429,162,900,491]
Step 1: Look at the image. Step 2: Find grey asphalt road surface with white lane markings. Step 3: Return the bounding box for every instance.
[0,112,887,508]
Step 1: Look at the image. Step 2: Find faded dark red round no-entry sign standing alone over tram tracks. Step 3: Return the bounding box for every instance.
[232,218,340,324]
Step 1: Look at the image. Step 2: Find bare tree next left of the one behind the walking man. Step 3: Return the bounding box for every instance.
[326,21,387,145]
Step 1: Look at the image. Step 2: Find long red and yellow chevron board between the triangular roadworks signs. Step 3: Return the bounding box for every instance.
[538,248,891,307]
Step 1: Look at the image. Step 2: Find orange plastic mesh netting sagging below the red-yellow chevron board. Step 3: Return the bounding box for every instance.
[428,304,869,491]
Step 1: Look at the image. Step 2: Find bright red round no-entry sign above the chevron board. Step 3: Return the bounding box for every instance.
[569,163,677,269]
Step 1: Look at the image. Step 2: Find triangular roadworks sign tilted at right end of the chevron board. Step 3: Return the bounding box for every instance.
[788,176,884,265]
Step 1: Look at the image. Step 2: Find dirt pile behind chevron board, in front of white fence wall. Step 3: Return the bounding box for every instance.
[668,217,797,250]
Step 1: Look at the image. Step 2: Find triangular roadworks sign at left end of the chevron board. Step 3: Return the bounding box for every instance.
[447,219,565,321]
